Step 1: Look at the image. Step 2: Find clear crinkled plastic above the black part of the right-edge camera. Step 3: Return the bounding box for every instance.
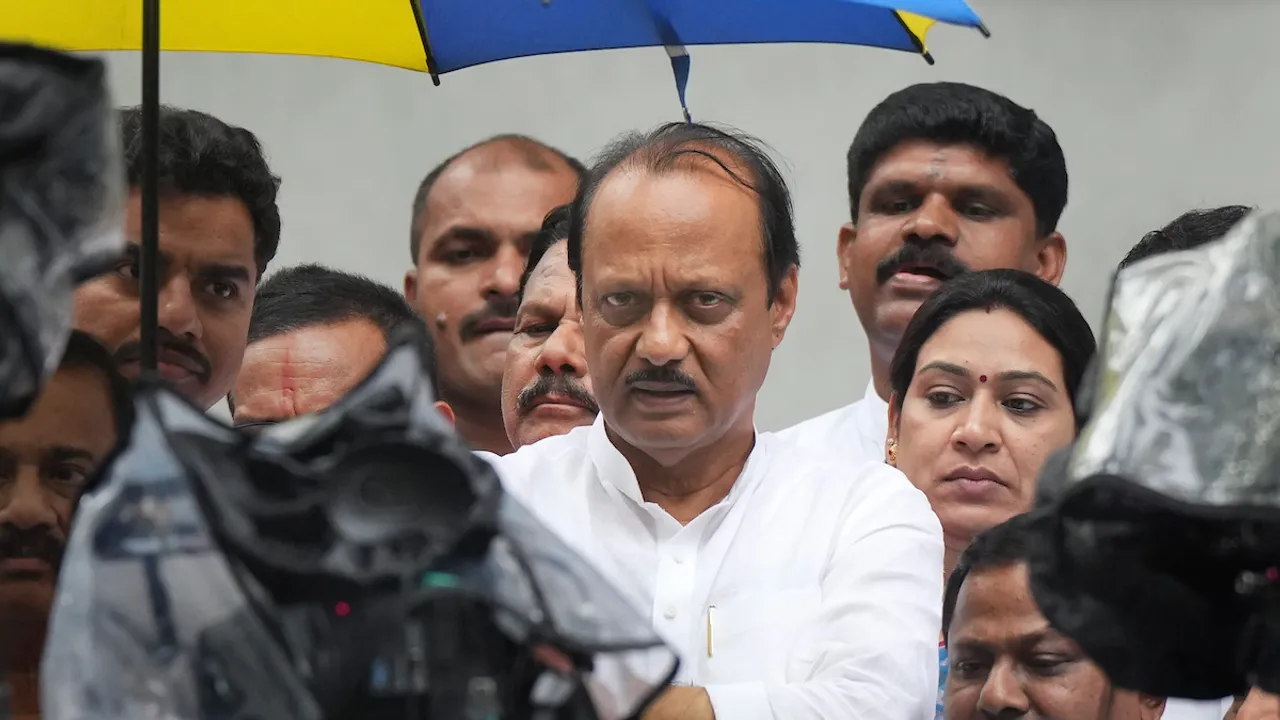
[1065,213,1280,509]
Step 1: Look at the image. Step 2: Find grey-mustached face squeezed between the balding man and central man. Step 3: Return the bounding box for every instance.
[502,242,599,447]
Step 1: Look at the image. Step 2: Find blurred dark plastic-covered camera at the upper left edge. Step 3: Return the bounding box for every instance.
[0,42,125,416]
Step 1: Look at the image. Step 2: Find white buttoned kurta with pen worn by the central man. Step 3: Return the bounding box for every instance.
[479,415,942,720]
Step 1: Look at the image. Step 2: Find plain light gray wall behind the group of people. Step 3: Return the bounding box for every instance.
[97,0,1280,429]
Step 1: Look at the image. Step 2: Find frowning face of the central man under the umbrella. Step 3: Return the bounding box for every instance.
[582,161,796,464]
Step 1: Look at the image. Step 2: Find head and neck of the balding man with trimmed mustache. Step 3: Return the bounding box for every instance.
[404,135,584,455]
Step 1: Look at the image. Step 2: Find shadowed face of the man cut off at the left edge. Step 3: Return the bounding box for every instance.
[0,368,118,623]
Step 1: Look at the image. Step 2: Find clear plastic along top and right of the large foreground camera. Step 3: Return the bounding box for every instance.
[255,336,677,720]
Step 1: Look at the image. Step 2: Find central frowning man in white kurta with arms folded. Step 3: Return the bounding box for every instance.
[484,123,942,720]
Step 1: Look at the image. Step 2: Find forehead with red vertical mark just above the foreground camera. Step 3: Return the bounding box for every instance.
[232,320,453,427]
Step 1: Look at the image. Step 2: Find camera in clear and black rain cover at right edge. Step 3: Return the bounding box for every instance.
[1030,206,1280,698]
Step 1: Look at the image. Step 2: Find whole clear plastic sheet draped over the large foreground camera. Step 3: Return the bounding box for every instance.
[41,333,677,720]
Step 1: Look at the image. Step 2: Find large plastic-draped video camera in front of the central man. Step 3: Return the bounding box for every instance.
[41,333,676,720]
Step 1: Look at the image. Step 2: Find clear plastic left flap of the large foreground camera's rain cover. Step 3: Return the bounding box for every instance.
[40,384,319,720]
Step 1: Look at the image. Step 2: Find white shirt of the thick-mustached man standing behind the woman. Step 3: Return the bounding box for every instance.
[778,383,888,468]
